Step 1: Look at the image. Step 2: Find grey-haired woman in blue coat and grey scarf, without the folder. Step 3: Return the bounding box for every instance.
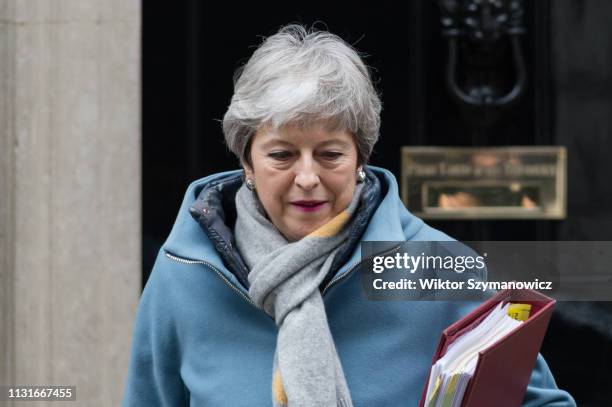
[124,25,574,407]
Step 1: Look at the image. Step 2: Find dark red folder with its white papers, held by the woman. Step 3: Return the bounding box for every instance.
[419,290,555,407]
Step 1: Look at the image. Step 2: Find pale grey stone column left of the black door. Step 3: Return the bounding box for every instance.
[0,0,141,406]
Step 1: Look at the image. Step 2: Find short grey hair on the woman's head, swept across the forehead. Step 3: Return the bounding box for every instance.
[223,24,381,164]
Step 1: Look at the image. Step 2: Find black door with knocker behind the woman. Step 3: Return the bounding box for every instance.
[142,0,612,406]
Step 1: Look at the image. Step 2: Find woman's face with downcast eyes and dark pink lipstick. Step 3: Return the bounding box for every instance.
[245,123,358,241]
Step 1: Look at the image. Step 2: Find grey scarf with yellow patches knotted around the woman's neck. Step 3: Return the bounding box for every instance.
[235,184,363,407]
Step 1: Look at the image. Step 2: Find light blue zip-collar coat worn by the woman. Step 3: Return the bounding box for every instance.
[123,167,575,407]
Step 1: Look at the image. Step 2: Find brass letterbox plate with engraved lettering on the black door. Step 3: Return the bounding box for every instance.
[401,146,567,219]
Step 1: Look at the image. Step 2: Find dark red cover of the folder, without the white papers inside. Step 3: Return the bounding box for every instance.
[419,290,555,407]
